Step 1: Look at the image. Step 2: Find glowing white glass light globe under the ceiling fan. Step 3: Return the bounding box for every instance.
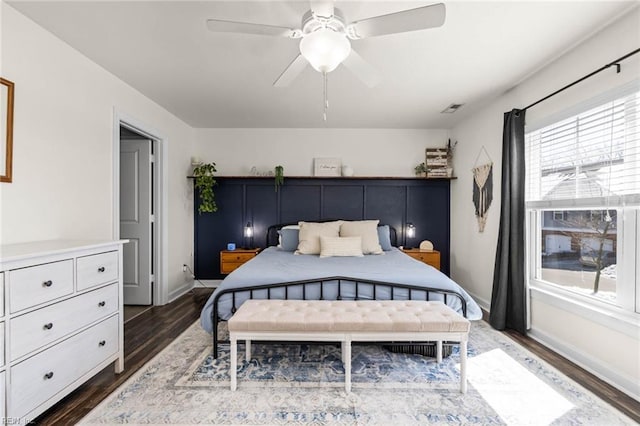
[300,28,351,73]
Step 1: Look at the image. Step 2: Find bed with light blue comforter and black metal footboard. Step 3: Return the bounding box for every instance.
[200,221,482,357]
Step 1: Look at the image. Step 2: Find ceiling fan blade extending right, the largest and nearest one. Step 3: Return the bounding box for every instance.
[347,3,446,39]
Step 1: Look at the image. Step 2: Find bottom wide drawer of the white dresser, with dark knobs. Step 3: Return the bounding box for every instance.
[7,315,118,418]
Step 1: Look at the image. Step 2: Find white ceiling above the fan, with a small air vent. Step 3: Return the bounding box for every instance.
[10,0,637,128]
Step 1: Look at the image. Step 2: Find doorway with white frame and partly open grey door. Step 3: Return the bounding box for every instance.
[113,112,167,312]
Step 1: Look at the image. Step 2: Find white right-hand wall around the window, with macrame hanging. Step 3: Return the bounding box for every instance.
[451,8,640,398]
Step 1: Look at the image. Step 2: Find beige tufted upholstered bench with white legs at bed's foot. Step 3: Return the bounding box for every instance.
[228,300,470,393]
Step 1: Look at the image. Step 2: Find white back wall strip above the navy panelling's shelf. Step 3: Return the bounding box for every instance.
[195,129,448,177]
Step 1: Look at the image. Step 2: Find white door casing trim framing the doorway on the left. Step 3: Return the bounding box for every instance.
[112,107,169,305]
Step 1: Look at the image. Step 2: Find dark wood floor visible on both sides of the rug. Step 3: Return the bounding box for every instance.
[34,289,640,425]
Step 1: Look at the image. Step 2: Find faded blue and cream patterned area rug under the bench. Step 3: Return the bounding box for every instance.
[81,321,635,426]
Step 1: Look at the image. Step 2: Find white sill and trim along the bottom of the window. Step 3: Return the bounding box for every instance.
[531,281,640,339]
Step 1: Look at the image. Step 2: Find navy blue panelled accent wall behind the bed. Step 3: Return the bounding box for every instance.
[194,177,450,279]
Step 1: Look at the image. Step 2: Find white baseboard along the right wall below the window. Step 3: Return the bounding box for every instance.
[527,327,640,401]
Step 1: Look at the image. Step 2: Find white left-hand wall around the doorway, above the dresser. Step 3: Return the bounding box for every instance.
[0,2,194,302]
